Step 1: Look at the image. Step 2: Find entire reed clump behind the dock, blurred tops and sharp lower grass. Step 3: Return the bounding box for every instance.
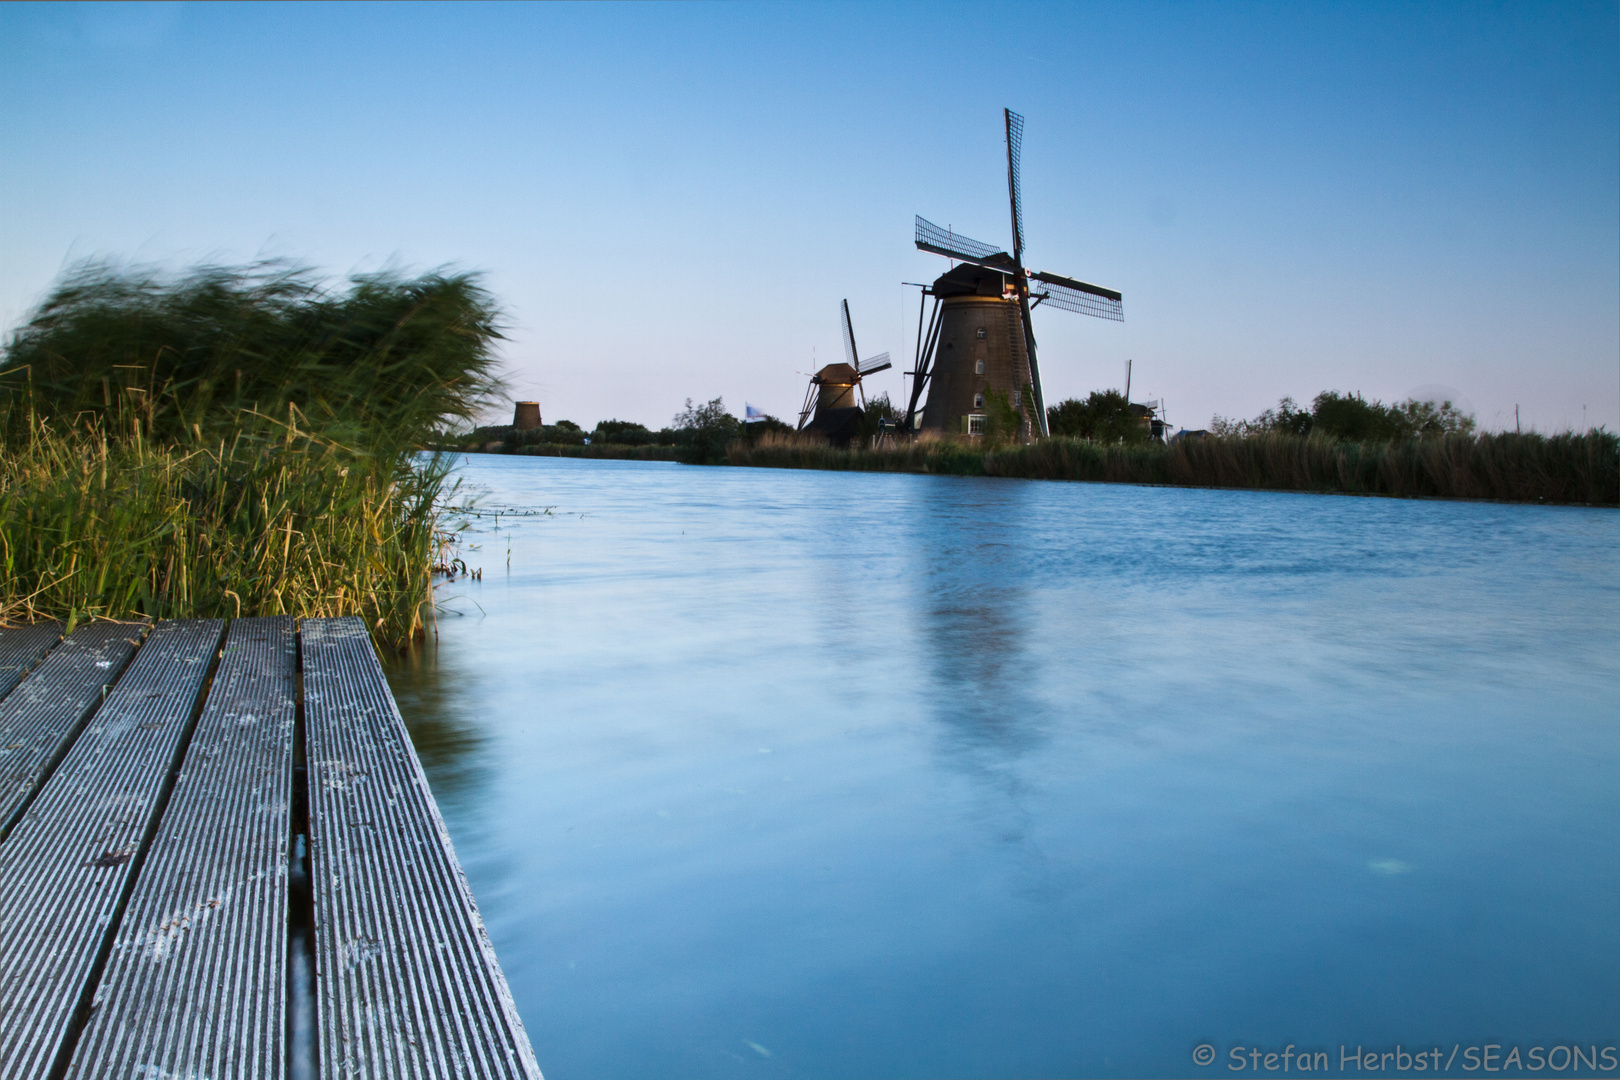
[0,262,501,648]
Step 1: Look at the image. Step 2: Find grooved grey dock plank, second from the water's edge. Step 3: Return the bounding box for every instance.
[66,619,296,1080]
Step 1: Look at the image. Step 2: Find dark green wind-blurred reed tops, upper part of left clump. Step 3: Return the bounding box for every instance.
[0,262,501,449]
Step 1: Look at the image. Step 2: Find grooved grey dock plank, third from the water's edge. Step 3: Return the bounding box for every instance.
[0,620,224,1080]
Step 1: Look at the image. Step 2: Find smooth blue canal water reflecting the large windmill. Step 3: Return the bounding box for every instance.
[390,457,1620,1080]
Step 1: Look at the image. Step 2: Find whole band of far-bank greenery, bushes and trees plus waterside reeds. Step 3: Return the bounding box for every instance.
[460,390,1620,507]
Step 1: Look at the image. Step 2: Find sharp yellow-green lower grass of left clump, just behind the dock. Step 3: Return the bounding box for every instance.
[0,411,447,646]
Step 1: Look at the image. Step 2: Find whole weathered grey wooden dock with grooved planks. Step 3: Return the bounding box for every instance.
[0,619,539,1080]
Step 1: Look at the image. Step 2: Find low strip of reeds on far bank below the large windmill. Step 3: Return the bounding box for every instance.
[729,431,1620,505]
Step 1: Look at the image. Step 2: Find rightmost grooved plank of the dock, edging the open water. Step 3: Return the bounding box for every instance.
[300,619,539,1080]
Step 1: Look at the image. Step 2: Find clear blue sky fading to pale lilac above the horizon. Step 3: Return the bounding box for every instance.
[0,3,1620,429]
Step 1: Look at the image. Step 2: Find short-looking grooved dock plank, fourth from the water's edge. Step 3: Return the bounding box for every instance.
[0,622,146,837]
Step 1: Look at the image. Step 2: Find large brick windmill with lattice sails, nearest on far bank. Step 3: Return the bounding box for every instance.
[904,108,1124,439]
